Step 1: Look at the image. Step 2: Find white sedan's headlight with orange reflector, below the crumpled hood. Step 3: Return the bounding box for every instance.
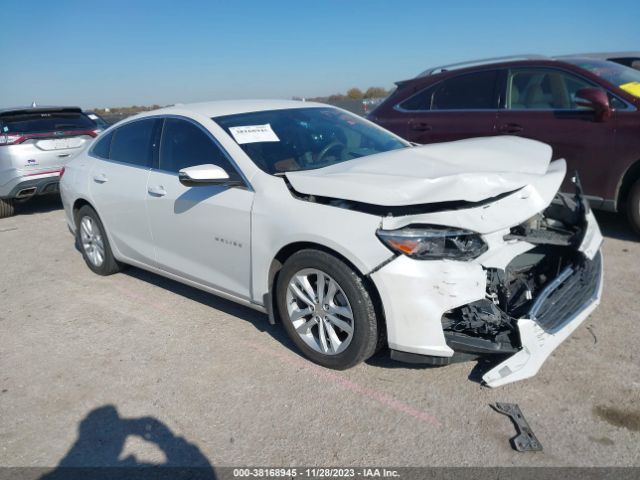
[376,226,487,260]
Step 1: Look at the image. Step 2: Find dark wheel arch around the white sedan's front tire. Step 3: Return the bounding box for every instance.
[265,241,386,334]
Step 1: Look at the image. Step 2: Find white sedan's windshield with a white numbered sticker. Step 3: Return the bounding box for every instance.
[213,107,409,174]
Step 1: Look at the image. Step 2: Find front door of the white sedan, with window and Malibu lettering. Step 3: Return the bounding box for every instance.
[147,117,254,299]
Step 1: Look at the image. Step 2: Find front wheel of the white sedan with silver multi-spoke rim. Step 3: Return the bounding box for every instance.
[276,250,379,370]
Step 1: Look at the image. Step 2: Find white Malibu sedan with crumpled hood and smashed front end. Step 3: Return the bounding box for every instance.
[61,101,602,387]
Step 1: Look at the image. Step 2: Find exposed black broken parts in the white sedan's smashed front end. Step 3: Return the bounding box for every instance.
[442,194,600,361]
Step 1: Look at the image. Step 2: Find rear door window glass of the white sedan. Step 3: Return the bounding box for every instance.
[109,118,157,167]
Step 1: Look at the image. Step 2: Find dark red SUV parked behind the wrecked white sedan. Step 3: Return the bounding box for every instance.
[369,57,640,233]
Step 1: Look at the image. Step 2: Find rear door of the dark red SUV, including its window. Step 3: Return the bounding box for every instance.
[394,70,499,143]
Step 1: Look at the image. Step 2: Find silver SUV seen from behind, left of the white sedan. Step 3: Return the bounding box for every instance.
[0,107,99,218]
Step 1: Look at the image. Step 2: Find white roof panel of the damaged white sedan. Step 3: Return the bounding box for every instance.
[142,100,330,118]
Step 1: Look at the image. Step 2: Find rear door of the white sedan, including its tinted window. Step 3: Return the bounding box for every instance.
[89,118,162,265]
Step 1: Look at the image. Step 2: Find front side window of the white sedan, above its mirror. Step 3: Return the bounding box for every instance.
[160,118,240,180]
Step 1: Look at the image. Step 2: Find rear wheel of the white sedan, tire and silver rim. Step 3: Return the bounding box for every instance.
[76,205,122,276]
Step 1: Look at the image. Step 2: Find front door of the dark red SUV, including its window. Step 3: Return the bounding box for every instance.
[497,67,616,200]
